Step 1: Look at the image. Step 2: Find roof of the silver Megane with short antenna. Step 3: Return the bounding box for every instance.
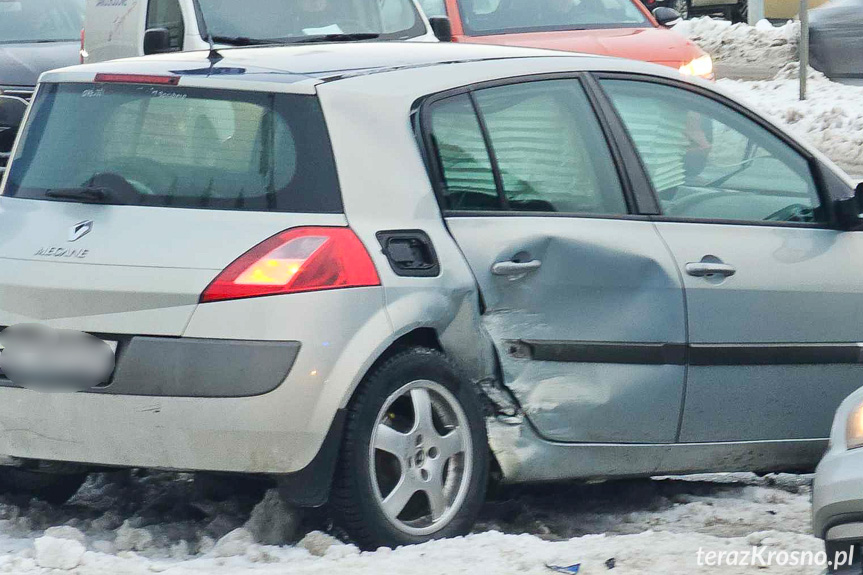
[41,42,600,93]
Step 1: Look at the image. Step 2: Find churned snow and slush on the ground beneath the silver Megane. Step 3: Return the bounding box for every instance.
[0,473,822,575]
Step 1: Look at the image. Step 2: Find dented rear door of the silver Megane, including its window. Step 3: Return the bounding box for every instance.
[424,79,686,443]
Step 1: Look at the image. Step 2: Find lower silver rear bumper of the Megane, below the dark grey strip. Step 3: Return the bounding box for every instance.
[0,385,335,473]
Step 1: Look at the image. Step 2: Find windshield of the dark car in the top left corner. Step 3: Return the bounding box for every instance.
[0,0,84,44]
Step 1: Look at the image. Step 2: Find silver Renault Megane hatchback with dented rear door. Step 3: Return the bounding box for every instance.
[0,43,863,548]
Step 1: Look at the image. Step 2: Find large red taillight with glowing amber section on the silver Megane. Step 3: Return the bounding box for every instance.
[201,227,381,303]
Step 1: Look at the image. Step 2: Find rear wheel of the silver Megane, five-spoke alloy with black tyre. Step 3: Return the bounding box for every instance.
[330,349,489,550]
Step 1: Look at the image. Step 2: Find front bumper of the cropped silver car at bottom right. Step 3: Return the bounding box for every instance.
[812,450,863,542]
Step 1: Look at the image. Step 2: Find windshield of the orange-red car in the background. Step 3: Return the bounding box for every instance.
[458,0,651,36]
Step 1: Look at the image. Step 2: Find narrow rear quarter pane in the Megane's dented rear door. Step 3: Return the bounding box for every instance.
[431,95,500,210]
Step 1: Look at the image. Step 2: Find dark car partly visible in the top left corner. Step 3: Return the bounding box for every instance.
[0,0,84,173]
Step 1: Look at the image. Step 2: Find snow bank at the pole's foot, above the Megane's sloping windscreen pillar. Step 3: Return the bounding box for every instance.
[718,68,863,172]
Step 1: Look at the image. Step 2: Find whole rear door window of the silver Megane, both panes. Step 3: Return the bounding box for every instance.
[431,80,627,215]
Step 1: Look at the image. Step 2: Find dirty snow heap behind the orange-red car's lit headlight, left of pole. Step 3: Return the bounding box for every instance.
[674,17,800,66]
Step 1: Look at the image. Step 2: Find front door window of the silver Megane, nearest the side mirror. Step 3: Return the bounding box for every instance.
[602,80,823,222]
